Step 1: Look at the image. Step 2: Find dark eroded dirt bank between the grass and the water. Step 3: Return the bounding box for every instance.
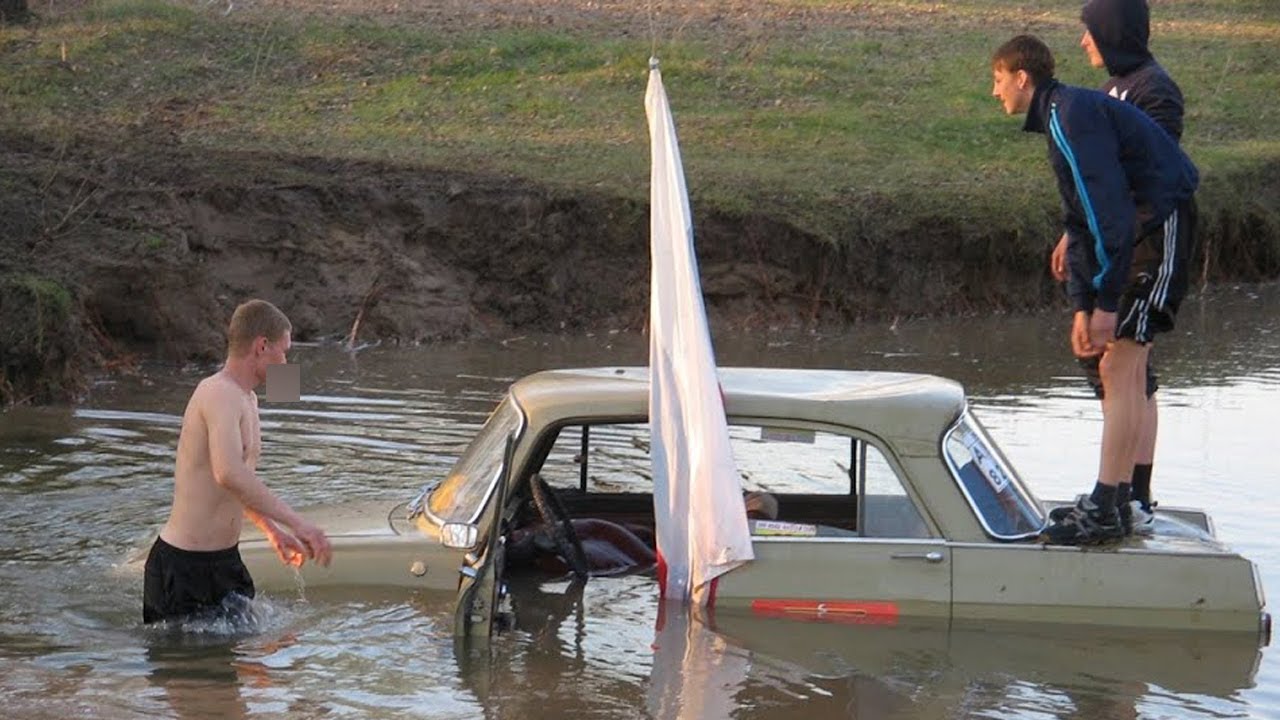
[0,131,1280,402]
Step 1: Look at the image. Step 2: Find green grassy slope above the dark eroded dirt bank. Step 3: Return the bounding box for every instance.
[0,0,1280,243]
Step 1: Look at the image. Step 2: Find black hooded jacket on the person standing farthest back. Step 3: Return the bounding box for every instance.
[1080,0,1183,140]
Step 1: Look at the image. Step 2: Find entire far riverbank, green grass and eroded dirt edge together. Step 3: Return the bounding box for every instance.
[0,0,1280,406]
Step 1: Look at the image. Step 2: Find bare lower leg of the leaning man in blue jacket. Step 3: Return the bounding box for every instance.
[1098,340,1149,486]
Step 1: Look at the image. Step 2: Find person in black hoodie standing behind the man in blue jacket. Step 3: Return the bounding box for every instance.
[1050,0,1183,533]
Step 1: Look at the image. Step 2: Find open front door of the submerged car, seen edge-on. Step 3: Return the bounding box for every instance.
[453,434,516,639]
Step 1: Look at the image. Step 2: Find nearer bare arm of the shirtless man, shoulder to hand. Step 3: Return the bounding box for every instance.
[204,388,330,565]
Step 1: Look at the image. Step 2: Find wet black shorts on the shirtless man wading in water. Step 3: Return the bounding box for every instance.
[142,538,253,623]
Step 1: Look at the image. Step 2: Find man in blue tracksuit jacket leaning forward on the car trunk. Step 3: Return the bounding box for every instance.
[992,35,1199,544]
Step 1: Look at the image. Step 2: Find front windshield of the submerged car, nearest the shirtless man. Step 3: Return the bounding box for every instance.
[428,396,524,523]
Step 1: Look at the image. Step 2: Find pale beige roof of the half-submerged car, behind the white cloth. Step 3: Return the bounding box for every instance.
[512,368,965,455]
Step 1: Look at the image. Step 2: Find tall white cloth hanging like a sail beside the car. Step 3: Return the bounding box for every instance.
[645,60,754,603]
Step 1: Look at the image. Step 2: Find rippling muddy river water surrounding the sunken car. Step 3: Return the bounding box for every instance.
[0,286,1280,720]
